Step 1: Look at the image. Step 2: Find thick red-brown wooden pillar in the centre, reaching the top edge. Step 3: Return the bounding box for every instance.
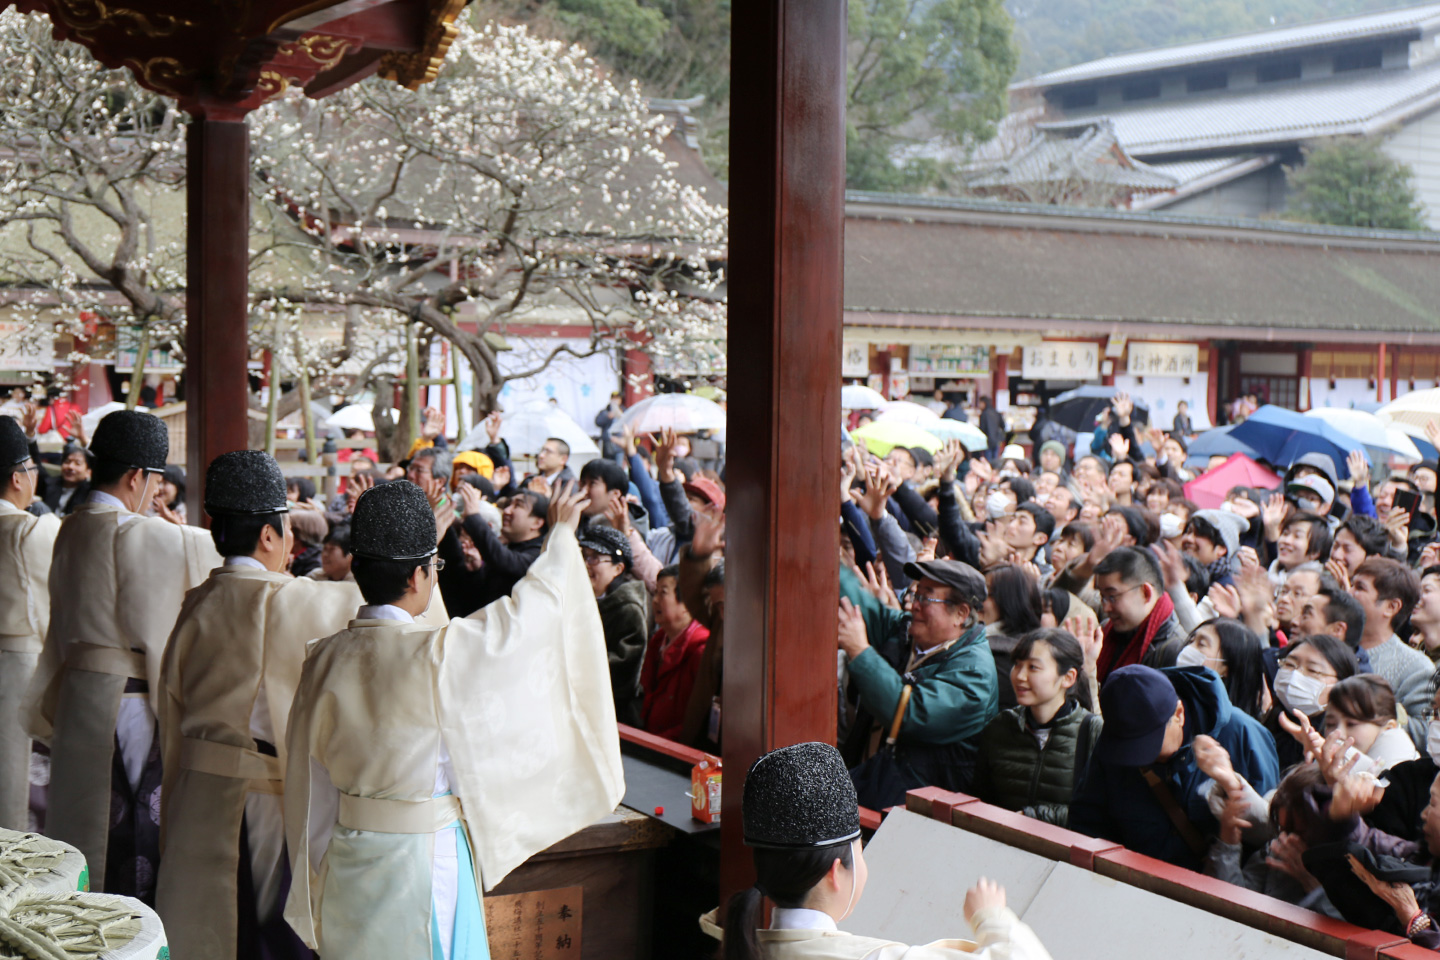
[720,0,845,915]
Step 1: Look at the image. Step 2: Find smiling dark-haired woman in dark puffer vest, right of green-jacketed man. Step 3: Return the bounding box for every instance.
[973,629,1100,826]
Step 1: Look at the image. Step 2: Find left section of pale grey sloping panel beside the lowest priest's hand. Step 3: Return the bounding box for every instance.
[841,810,1064,959]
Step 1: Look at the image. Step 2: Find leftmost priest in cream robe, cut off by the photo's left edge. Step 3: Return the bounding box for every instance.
[0,416,60,830]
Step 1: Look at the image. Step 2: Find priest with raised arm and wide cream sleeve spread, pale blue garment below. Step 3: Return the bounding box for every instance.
[285,481,625,960]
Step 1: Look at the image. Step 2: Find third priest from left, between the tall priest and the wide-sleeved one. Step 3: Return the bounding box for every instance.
[156,450,360,960]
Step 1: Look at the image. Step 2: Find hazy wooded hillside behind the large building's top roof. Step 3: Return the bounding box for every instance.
[1005,0,1404,76]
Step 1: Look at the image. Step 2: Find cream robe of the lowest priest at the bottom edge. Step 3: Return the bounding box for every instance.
[756,907,1050,960]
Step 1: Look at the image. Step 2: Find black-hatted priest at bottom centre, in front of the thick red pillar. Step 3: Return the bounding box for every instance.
[717,743,1050,960]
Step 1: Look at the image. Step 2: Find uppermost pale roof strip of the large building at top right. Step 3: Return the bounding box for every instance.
[1014,3,1440,88]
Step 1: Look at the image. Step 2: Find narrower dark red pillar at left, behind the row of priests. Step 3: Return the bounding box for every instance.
[184,114,251,517]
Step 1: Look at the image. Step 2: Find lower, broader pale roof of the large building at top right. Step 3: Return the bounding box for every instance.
[1040,62,1440,157]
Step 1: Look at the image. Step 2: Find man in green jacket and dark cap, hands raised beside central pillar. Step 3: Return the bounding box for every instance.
[840,560,999,809]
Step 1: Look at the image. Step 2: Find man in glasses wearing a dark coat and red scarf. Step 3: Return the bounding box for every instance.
[1094,547,1185,684]
